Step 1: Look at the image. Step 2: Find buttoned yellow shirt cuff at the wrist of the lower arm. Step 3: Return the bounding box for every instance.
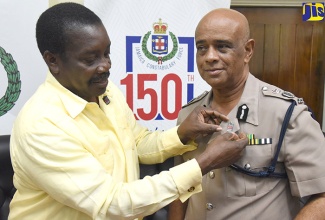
[170,159,202,202]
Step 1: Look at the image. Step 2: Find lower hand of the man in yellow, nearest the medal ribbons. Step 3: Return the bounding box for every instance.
[196,132,248,175]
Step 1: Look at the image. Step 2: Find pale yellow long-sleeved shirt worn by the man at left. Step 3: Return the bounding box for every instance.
[9,74,202,220]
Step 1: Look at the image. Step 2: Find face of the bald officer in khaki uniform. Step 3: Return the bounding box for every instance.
[195,11,250,89]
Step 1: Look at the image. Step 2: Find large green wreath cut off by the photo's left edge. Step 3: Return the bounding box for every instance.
[0,47,21,116]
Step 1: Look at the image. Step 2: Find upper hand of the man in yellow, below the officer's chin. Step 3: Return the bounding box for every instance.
[177,106,228,144]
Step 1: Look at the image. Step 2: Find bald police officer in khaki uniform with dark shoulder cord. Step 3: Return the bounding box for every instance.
[169,9,325,220]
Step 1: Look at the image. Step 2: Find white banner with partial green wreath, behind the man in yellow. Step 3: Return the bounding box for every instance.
[0,0,48,135]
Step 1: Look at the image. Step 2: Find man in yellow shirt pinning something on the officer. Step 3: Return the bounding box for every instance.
[9,3,248,220]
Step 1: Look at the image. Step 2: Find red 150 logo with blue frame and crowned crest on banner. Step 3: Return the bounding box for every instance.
[120,18,194,125]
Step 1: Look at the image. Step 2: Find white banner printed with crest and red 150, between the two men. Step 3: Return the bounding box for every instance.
[84,0,230,130]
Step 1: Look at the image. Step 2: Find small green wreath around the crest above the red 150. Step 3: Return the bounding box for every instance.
[142,31,178,62]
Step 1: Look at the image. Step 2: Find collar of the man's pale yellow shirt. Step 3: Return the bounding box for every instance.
[45,72,107,118]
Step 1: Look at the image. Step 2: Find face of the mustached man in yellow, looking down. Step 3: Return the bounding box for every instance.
[54,24,111,102]
